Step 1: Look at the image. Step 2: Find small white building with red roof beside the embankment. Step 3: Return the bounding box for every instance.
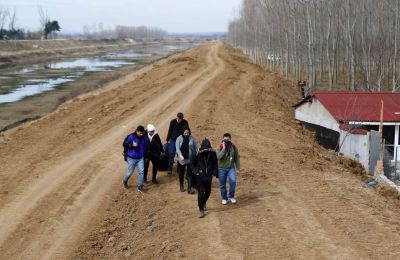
[294,91,400,174]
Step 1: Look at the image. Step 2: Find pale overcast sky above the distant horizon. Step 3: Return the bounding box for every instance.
[0,0,242,33]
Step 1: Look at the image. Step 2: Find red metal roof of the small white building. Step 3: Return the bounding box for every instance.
[295,91,400,122]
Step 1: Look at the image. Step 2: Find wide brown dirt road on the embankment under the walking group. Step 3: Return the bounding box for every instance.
[0,42,400,259]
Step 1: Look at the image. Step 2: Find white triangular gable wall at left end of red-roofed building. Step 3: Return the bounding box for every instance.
[295,97,340,132]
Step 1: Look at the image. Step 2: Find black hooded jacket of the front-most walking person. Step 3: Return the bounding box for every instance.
[192,139,218,180]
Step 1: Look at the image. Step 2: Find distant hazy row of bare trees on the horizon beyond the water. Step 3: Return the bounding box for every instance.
[83,23,168,41]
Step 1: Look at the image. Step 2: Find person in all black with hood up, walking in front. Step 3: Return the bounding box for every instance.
[191,138,218,218]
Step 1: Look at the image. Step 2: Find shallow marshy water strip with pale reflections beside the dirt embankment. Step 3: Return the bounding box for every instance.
[0,44,193,105]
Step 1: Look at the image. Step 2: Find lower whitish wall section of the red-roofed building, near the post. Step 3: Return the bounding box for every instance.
[339,130,369,172]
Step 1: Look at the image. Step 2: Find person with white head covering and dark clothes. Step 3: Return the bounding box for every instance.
[144,124,164,184]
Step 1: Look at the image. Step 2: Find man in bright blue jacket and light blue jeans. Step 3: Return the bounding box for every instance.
[122,125,148,192]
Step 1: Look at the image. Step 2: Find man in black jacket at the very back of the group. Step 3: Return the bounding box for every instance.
[167,112,189,174]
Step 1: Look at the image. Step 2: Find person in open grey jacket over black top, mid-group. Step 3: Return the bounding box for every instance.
[176,127,197,194]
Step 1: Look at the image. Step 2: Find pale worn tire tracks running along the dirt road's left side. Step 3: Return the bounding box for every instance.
[0,41,219,257]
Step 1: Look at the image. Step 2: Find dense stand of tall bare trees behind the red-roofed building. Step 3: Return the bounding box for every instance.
[228,0,400,92]
